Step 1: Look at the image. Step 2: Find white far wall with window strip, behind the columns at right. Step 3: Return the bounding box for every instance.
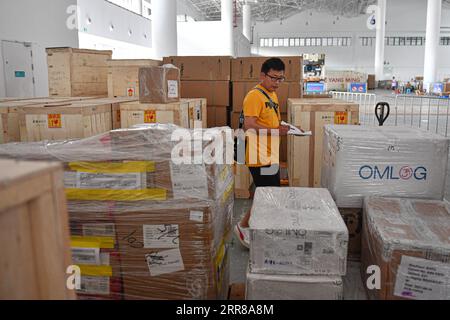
[252,0,450,80]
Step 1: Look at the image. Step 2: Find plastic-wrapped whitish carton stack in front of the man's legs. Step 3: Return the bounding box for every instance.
[246,187,348,300]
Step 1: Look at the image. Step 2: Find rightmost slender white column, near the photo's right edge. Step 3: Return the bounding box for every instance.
[423,0,442,89]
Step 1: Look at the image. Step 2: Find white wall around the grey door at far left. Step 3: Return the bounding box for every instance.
[0,0,78,97]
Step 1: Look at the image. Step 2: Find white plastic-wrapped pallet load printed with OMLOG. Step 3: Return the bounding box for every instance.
[322,125,449,208]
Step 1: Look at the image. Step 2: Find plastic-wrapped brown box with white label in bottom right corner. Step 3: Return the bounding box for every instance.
[361,197,450,300]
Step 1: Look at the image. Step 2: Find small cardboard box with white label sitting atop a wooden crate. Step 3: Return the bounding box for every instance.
[139,65,181,103]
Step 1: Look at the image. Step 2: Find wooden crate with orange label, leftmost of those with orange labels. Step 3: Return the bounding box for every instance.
[19,100,113,142]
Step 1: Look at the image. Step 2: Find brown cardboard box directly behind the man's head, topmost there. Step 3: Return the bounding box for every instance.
[231,56,303,83]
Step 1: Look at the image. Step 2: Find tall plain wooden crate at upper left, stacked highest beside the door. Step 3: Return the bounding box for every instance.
[47,48,112,97]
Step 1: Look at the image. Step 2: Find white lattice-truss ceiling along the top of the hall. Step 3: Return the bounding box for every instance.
[185,0,450,21]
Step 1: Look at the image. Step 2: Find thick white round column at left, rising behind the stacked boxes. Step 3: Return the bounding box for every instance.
[152,0,178,58]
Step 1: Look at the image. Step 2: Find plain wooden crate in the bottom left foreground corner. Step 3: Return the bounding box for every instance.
[0,160,75,299]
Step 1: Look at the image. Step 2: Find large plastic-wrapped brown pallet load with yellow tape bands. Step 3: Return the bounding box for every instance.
[0,124,234,299]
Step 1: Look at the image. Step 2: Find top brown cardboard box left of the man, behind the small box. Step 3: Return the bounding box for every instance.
[163,56,231,80]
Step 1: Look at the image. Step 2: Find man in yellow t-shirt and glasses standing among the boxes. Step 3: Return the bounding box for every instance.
[234,58,296,248]
